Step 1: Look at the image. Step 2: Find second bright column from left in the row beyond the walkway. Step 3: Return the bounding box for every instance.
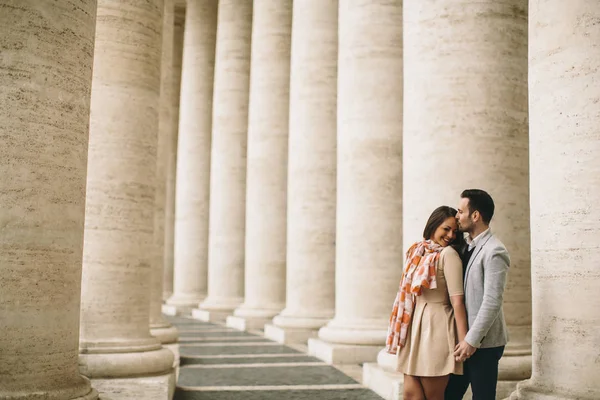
[193,0,252,321]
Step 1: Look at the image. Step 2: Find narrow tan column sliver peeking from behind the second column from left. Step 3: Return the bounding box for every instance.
[150,0,179,365]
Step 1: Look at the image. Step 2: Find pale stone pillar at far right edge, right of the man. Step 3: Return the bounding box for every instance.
[511,0,600,400]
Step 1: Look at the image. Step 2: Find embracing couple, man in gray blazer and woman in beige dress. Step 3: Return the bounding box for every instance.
[386,189,510,400]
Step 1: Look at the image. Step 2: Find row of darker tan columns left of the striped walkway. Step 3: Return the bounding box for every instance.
[0,0,178,400]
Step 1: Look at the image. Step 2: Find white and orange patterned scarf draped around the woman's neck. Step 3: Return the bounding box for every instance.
[385,240,443,354]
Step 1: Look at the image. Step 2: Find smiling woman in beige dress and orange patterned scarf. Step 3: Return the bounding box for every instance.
[386,206,467,400]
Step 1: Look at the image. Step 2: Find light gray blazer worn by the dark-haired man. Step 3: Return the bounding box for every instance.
[465,230,510,348]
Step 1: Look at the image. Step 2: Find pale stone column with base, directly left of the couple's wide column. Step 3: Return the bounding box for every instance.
[309,0,403,363]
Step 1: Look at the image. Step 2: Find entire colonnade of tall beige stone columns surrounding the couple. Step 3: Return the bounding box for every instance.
[0,0,600,399]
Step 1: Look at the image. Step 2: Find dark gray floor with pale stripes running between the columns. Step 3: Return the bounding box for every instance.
[167,317,381,400]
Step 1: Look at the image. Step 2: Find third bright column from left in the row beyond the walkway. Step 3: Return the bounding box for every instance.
[227,0,292,330]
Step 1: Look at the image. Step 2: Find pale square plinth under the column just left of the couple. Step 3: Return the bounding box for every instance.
[308,339,381,364]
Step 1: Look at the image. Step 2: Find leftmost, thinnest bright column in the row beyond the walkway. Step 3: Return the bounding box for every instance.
[167,0,218,313]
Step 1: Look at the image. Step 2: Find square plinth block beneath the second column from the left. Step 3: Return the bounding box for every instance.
[92,370,175,400]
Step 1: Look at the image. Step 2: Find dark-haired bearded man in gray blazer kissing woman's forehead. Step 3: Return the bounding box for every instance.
[444,189,510,400]
